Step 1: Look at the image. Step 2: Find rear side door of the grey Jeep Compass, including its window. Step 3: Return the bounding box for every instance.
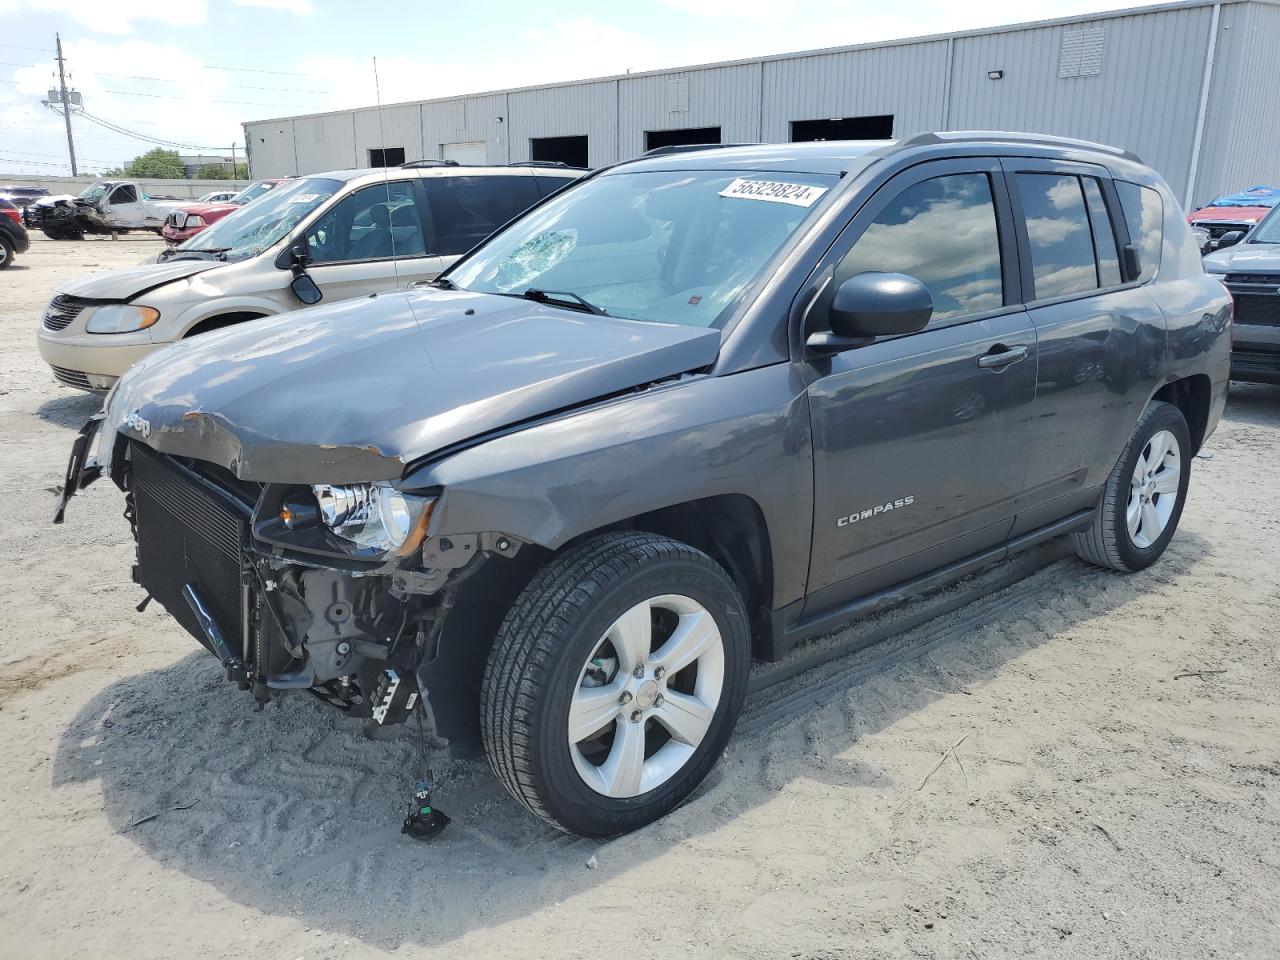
[1004,157,1166,535]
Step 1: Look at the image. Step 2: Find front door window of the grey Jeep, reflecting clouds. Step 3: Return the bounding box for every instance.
[836,173,1005,324]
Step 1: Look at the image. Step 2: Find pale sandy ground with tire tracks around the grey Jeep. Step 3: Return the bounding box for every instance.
[0,239,1280,960]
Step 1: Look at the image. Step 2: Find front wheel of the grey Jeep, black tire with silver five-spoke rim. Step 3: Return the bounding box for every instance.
[480,532,751,837]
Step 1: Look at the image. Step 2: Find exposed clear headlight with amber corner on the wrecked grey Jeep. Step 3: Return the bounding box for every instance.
[309,483,435,557]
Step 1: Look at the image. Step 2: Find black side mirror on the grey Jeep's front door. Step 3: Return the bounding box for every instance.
[805,273,933,353]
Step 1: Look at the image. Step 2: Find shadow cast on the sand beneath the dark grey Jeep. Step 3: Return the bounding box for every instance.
[52,531,1208,950]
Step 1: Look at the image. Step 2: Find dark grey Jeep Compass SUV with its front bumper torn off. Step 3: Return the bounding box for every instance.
[59,133,1231,836]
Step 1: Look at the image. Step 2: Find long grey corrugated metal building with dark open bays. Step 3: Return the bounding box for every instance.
[244,0,1280,208]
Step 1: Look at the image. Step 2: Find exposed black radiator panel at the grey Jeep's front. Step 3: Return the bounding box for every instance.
[129,443,250,655]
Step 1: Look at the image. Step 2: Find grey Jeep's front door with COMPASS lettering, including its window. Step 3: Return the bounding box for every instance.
[805,157,1037,616]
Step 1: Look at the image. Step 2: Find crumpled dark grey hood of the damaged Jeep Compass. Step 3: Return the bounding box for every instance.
[108,291,719,483]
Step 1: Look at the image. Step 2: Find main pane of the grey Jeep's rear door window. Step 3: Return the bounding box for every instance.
[1016,173,1098,300]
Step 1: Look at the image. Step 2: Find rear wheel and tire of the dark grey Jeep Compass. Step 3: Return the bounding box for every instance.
[1073,401,1192,573]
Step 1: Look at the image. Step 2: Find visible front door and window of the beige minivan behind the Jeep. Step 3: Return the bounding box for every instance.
[306,180,444,301]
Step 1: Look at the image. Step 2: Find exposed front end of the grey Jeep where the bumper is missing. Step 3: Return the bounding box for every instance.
[54,415,443,727]
